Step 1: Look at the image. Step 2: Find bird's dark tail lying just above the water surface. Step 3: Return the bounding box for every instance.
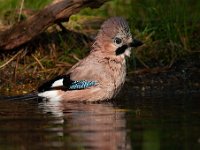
[0,92,41,100]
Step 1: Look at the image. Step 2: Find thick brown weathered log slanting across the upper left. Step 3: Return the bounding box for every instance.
[0,0,108,51]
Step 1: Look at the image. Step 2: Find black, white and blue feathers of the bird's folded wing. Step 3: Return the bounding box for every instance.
[38,74,97,92]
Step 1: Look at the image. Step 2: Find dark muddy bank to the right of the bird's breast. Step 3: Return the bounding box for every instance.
[124,56,200,95]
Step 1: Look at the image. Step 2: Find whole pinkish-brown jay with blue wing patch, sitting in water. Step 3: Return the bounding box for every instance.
[1,17,143,102]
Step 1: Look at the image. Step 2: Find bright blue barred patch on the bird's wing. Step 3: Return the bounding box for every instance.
[69,80,97,90]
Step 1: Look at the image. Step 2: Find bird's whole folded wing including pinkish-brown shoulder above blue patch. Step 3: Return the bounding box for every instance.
[38,55,108,92]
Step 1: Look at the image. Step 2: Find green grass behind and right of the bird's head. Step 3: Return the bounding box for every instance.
[76,0,200,67]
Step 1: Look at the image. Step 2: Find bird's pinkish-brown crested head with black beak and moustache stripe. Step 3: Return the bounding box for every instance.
[93,17,142,57]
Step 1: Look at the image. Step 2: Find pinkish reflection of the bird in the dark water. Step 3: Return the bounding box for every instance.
[41,102,131,150]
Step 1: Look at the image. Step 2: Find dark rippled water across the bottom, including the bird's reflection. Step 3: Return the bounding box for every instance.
[0,91,200,150]
